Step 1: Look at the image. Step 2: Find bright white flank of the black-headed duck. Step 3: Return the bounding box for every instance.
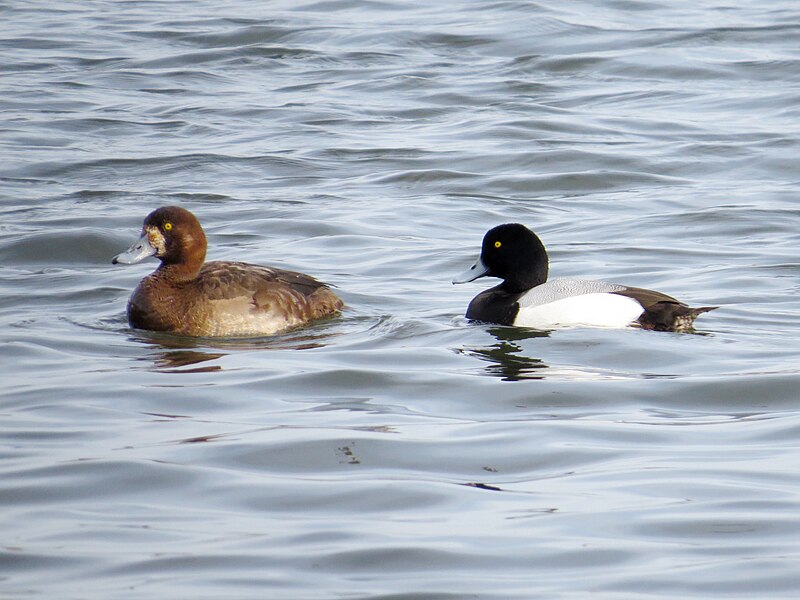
[514,288,644,329]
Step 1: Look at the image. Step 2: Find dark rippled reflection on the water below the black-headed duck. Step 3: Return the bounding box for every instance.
[460,327,550,381]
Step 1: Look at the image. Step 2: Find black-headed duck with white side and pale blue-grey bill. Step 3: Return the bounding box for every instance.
[453,223,719,332]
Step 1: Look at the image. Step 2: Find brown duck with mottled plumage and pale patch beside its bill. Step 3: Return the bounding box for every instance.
[111,206,343,337]
